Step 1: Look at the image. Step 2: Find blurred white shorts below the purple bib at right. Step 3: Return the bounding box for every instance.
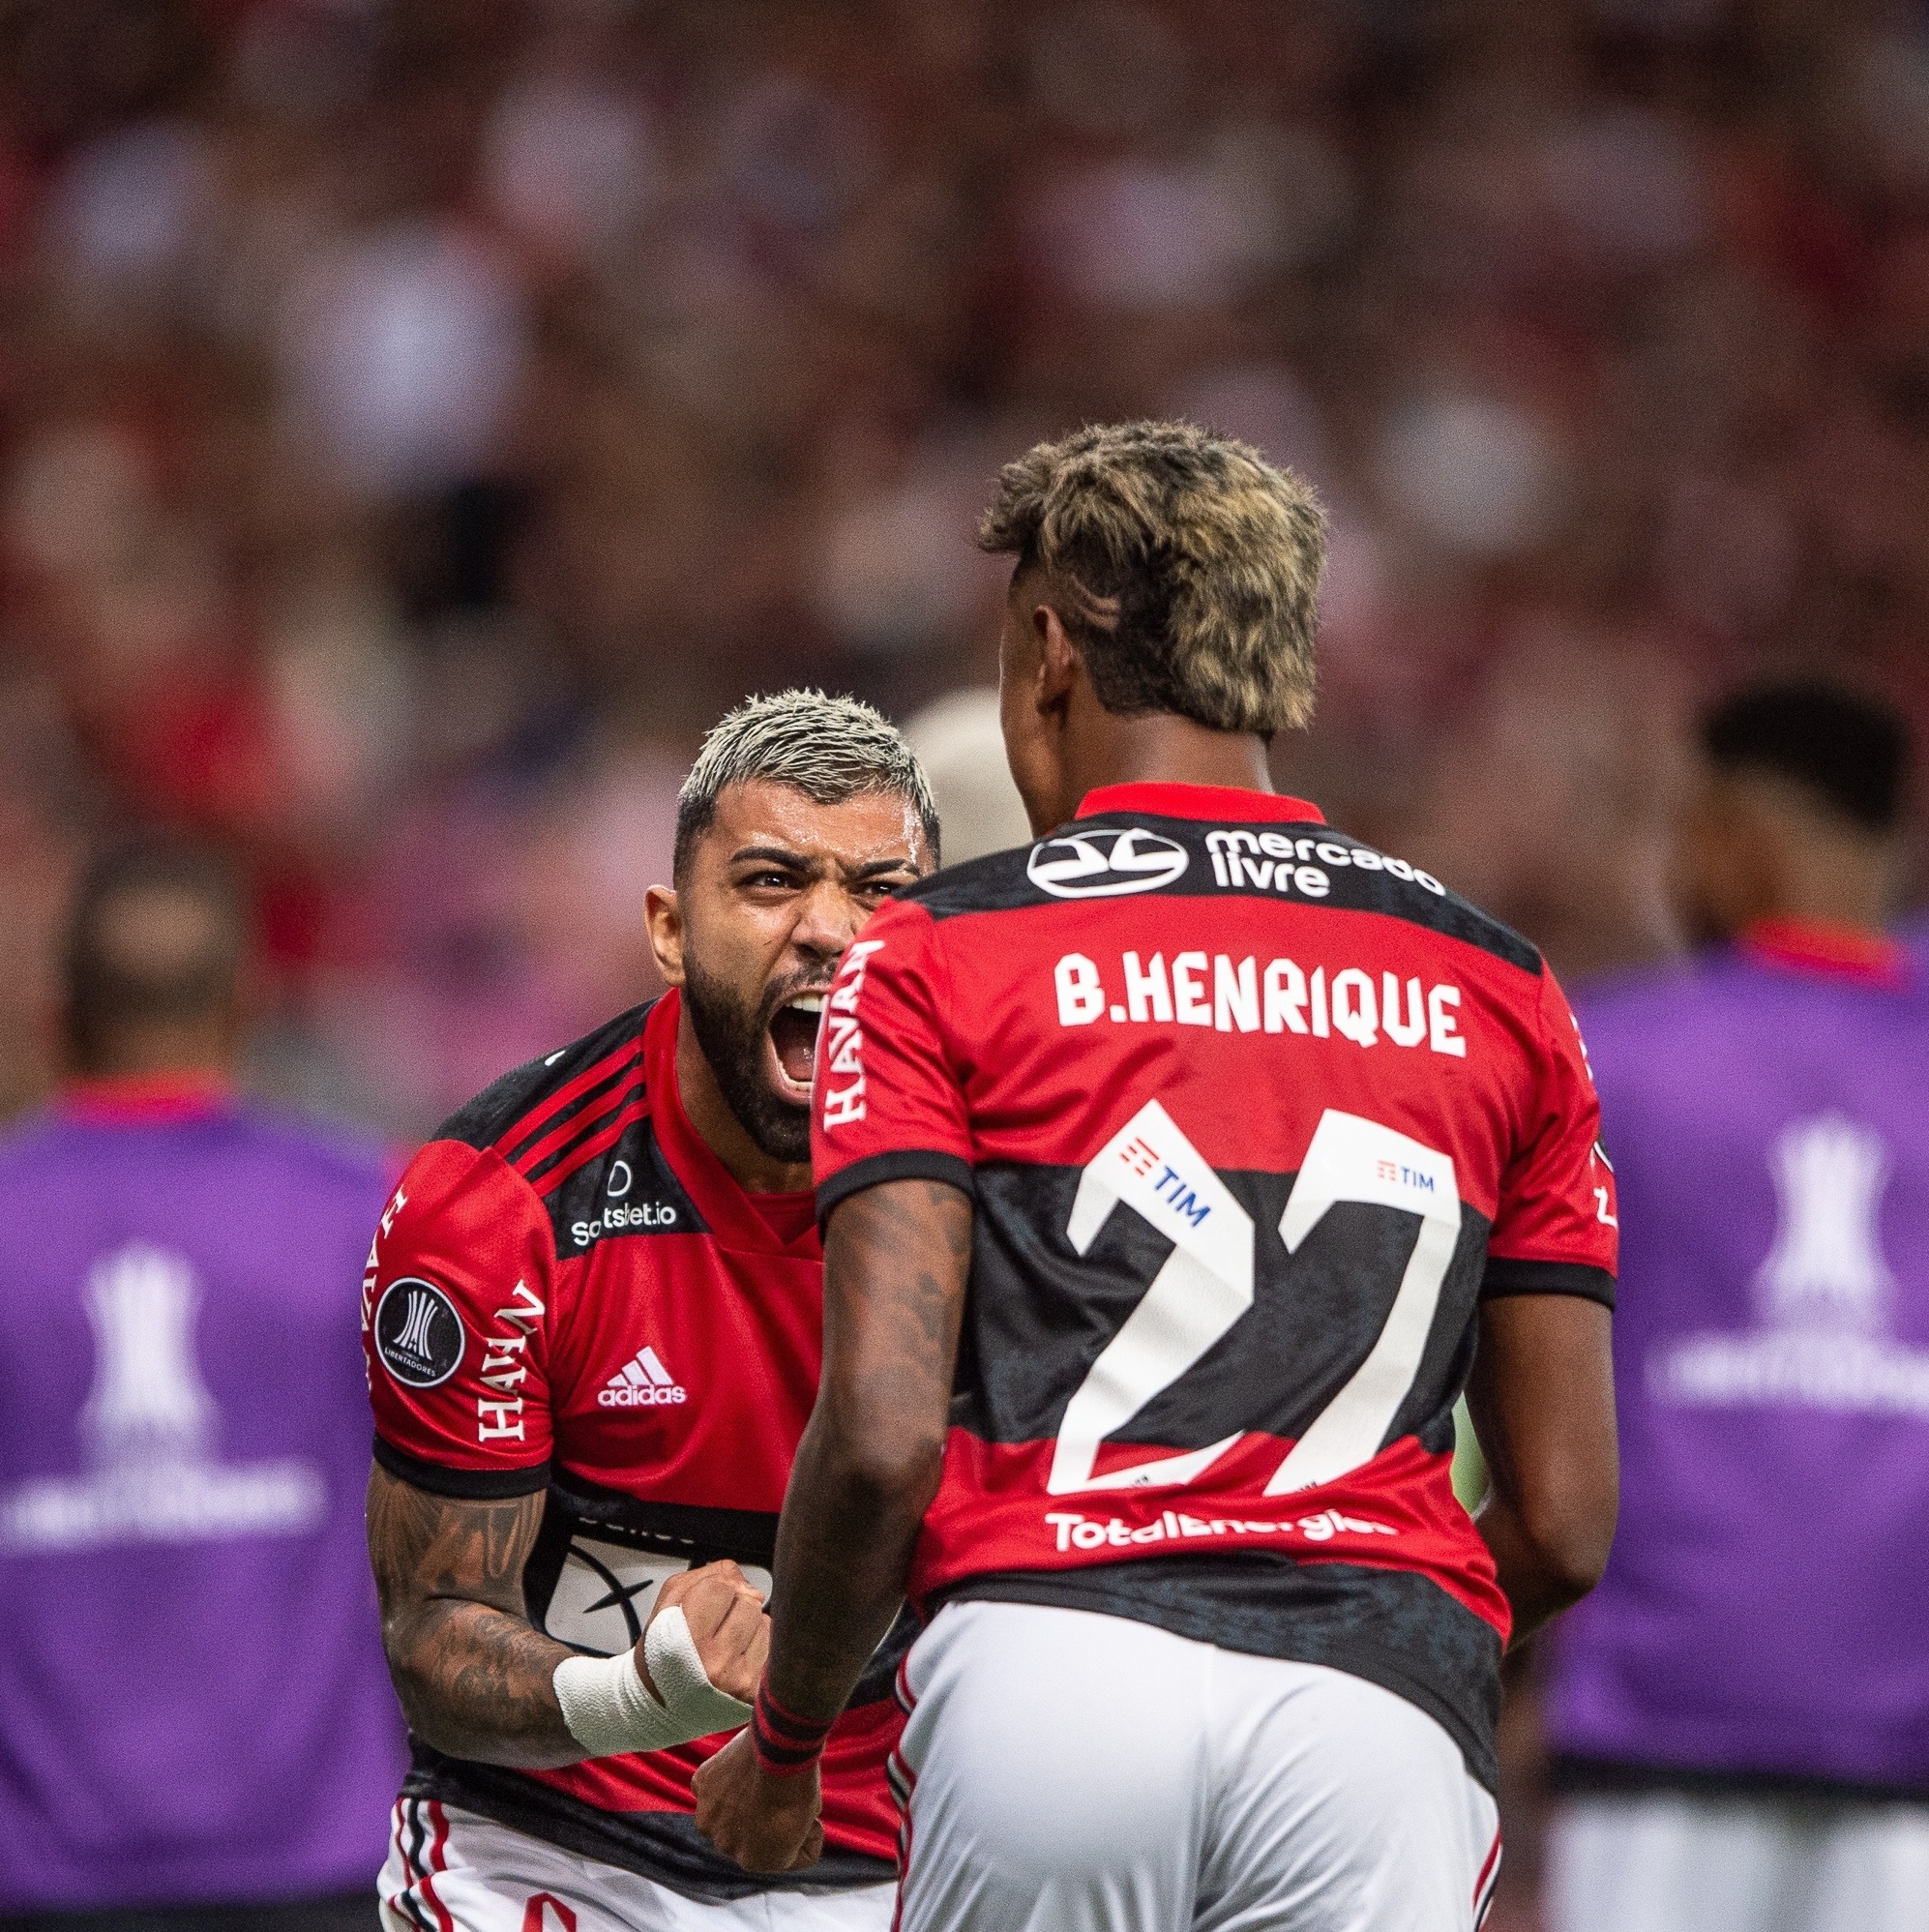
[1546,1793,1929,1932]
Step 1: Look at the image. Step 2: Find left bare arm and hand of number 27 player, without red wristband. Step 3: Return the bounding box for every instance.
[696,1180,972,1872]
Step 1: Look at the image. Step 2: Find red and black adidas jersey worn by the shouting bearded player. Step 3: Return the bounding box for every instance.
[362,993,910,1897]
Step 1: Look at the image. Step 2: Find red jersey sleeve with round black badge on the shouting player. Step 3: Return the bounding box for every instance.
[362,1140,554,1498]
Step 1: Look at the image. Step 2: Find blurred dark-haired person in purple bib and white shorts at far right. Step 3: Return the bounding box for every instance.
[1550,684,1929,1932]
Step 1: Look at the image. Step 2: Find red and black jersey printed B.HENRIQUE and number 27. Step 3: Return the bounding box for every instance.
[814,785,1616,1783]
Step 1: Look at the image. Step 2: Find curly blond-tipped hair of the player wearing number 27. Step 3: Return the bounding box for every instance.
[978,423,1326,738]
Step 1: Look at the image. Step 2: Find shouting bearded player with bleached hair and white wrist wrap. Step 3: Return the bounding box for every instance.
[364,692,937,1932]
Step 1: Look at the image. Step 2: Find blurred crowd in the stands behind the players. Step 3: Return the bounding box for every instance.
[0,0,1929,1136]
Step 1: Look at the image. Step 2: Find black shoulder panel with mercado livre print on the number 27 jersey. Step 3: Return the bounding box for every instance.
[897,814,1542,975]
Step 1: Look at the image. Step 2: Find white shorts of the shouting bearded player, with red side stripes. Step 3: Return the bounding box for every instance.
[377,1798,897,1932]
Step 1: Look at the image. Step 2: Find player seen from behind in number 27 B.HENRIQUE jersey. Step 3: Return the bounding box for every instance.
[696,423,1616,1932]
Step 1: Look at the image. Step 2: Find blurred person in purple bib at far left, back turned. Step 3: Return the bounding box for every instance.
[0,843,402,1932]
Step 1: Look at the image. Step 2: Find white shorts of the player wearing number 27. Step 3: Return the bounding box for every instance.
[893,1604,1507,1932]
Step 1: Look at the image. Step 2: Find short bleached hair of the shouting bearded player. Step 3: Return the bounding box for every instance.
[674,690,937,879]
